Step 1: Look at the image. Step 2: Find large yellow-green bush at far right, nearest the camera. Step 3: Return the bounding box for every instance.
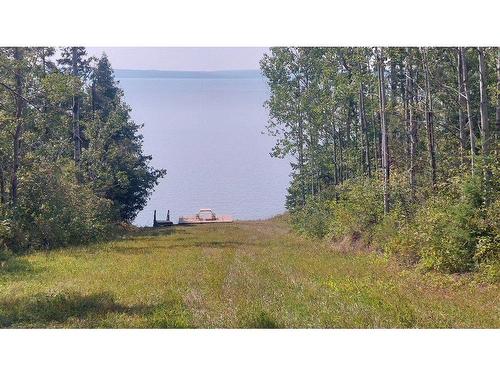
[384,177,500,272]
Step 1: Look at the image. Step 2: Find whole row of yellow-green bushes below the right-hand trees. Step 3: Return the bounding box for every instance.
[292,176,500,279]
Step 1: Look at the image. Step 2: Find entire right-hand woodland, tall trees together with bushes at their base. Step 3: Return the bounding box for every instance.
[261,47,500,280]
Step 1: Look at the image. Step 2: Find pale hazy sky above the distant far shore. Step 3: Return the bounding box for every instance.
[87,47,267,71]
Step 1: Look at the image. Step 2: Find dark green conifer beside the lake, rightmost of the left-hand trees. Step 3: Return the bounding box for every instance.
[82,55,166,222]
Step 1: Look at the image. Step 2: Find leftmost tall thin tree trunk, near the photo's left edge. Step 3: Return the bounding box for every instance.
[11,47,24,206]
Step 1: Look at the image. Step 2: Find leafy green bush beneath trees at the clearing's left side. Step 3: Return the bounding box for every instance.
[10,163,111,249]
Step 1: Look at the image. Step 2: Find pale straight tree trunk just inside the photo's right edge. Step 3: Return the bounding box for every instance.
[477,47,491,204]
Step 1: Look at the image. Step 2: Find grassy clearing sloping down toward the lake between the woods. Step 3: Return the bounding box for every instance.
[0,218,500,328]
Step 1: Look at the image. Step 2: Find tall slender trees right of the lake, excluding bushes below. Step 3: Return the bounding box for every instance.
[261,47,500,276]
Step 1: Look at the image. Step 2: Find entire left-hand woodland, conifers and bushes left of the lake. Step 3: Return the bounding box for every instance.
[0,47,165,253]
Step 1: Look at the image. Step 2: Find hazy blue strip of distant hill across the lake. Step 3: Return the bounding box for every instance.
[115,69,262,79]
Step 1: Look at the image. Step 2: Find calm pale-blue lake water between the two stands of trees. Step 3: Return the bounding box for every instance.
[117,76,289,226]
